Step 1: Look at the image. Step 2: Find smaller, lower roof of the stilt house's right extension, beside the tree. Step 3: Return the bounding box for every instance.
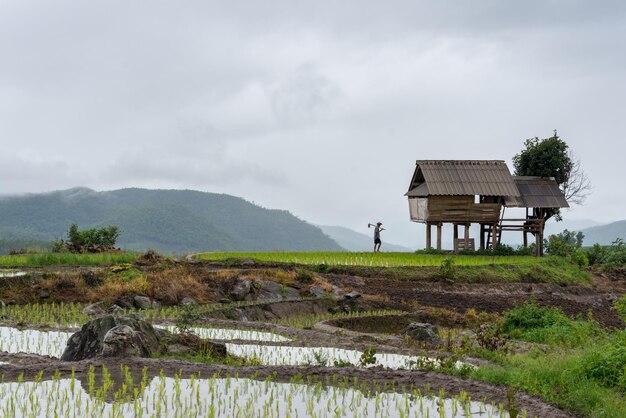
[504,176,569,208]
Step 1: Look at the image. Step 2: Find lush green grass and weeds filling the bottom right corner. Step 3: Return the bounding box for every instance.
[460,302,626,417]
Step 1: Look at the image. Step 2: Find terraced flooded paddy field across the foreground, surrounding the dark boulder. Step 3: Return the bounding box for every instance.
[0,255,621,417]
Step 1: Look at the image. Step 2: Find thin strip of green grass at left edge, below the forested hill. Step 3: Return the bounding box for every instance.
[0,253,139,267]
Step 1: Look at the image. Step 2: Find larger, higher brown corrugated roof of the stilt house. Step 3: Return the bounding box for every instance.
[407,160,520,196]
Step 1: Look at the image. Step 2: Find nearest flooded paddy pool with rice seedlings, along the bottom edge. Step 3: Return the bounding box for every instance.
[0,376,508,418]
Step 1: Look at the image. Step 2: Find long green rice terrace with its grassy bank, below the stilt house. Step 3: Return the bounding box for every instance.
[196,252,591,285]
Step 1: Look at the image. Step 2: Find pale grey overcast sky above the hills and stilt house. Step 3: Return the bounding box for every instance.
[0,0,626,244]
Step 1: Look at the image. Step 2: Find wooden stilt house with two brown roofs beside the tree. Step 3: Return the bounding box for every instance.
[405,160,567,255]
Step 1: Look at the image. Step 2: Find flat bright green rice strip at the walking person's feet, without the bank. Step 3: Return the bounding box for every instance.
[196,252,541,267]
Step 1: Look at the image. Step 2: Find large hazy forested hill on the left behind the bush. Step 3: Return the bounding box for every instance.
[0,188,342,253]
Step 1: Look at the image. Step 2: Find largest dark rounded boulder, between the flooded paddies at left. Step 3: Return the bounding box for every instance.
[61,315,161,361]
